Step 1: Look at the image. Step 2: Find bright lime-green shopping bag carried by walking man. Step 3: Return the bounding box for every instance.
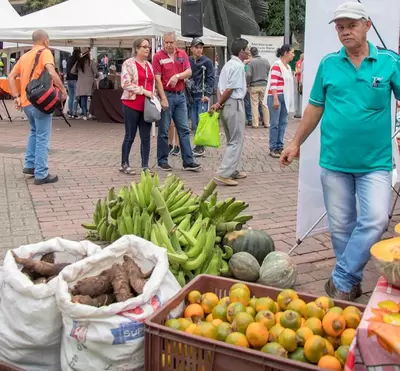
[194,112,221,148]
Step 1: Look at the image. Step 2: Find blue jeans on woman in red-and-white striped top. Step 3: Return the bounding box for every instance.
[268,94,289,152]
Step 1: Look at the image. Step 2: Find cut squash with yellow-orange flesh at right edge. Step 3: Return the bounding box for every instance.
[370,237,400,286]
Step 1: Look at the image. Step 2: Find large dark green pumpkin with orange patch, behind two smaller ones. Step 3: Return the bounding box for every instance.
[224,228,275,265]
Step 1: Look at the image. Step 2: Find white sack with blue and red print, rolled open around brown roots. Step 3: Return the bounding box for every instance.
[56,235,183,371]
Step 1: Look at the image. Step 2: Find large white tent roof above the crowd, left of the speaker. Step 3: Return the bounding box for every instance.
[0,0,227,47]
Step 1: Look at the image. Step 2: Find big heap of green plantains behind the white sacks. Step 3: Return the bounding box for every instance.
[82,171,252,285]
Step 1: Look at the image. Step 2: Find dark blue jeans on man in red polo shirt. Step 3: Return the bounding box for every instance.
[157,91,193,165]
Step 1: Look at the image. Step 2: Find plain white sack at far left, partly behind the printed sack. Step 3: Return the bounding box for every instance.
[0,238,101,371]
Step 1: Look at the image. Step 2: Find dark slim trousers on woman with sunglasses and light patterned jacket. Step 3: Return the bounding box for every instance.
[121,104,151,169]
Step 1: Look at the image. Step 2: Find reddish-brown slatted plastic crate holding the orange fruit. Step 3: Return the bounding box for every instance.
[145,275,365,371]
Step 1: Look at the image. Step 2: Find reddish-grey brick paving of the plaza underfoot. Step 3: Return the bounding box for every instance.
[0,100,400,303]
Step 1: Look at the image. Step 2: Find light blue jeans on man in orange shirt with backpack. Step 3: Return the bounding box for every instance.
[24,106,52,179]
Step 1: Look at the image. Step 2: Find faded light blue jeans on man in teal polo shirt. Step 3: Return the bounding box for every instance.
[321,169,392,292]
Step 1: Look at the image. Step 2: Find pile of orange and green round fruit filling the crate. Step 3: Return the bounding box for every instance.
[166,283,362,370]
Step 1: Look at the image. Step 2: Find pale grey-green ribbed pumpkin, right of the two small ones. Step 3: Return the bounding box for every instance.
[258,251,297,289]
